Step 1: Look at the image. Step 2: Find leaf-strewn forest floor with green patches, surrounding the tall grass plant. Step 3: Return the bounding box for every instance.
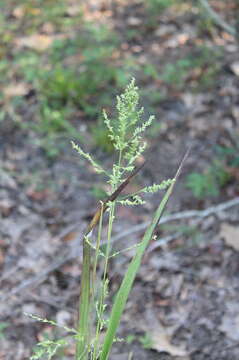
[0,0,239,360]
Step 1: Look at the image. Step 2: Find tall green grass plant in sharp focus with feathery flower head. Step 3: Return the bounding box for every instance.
[28,79,187,360]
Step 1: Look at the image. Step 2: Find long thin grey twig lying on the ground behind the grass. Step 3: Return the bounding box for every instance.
[0,197,239,302]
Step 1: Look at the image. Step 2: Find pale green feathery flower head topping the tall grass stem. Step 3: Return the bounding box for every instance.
[72,79,174,205]
